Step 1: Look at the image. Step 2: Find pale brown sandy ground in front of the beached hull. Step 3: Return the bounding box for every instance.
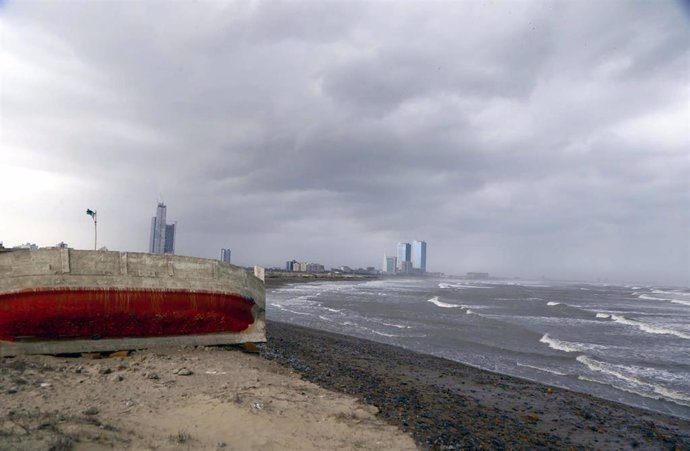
[0,347,416,450]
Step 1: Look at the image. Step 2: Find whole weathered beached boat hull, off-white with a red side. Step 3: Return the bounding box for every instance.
[0,249,266,356]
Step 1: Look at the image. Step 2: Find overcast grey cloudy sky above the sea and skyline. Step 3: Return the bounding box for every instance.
[0,0,690,285]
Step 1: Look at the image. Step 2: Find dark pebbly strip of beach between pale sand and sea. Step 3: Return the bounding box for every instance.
[260,322,690,450]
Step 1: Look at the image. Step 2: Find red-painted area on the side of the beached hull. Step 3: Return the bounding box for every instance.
[0,289,254,341]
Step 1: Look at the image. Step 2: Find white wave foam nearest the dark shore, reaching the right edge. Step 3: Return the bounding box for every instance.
[576,355,690,406]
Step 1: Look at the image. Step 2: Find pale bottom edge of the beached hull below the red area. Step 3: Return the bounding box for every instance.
[0,321,266,357]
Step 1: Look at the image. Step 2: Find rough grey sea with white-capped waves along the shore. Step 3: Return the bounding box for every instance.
[266,278,690,419]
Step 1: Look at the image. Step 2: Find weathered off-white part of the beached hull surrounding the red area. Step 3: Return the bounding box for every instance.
[0,249,266,355]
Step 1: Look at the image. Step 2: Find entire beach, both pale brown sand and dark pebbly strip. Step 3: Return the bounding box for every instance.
[0,322,690,450]
